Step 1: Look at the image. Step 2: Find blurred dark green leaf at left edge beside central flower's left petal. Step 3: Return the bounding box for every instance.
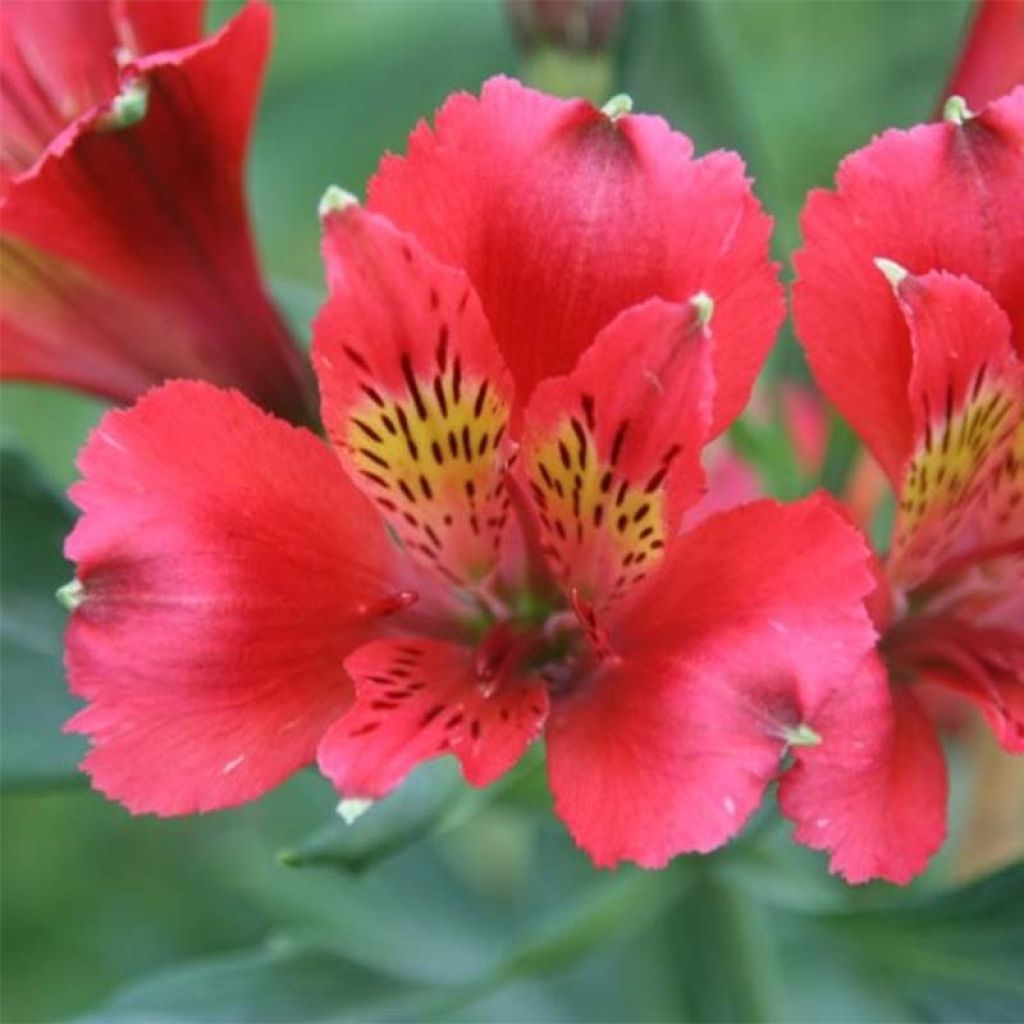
[0,447,83,788]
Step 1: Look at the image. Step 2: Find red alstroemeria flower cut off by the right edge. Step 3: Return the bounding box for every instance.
[782,88,1024,878]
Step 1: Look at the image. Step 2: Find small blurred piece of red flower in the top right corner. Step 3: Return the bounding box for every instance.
[946,0,1024,110]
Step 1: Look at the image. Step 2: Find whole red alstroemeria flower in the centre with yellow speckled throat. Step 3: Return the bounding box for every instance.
[61,80,874,865]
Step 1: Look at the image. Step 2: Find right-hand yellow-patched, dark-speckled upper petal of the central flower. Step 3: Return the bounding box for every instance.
[521,297,714,610]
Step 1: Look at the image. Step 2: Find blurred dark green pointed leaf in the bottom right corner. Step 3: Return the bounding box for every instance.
[817,862,1024,1024]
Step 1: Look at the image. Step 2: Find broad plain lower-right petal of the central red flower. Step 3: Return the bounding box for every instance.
[547,498,874,867]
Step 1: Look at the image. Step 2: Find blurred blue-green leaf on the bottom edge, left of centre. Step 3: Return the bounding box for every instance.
[76,941,436,1024]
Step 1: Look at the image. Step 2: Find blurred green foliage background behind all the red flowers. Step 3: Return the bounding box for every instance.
[2,0,1024,1022]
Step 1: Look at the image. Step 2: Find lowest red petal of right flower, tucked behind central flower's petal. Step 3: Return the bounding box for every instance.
[778,656,948,885]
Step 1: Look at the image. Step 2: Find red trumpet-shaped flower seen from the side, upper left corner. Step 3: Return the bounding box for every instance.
[0,0,309,422]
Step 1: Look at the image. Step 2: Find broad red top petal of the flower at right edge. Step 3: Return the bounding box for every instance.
[794,87,1024,484]
